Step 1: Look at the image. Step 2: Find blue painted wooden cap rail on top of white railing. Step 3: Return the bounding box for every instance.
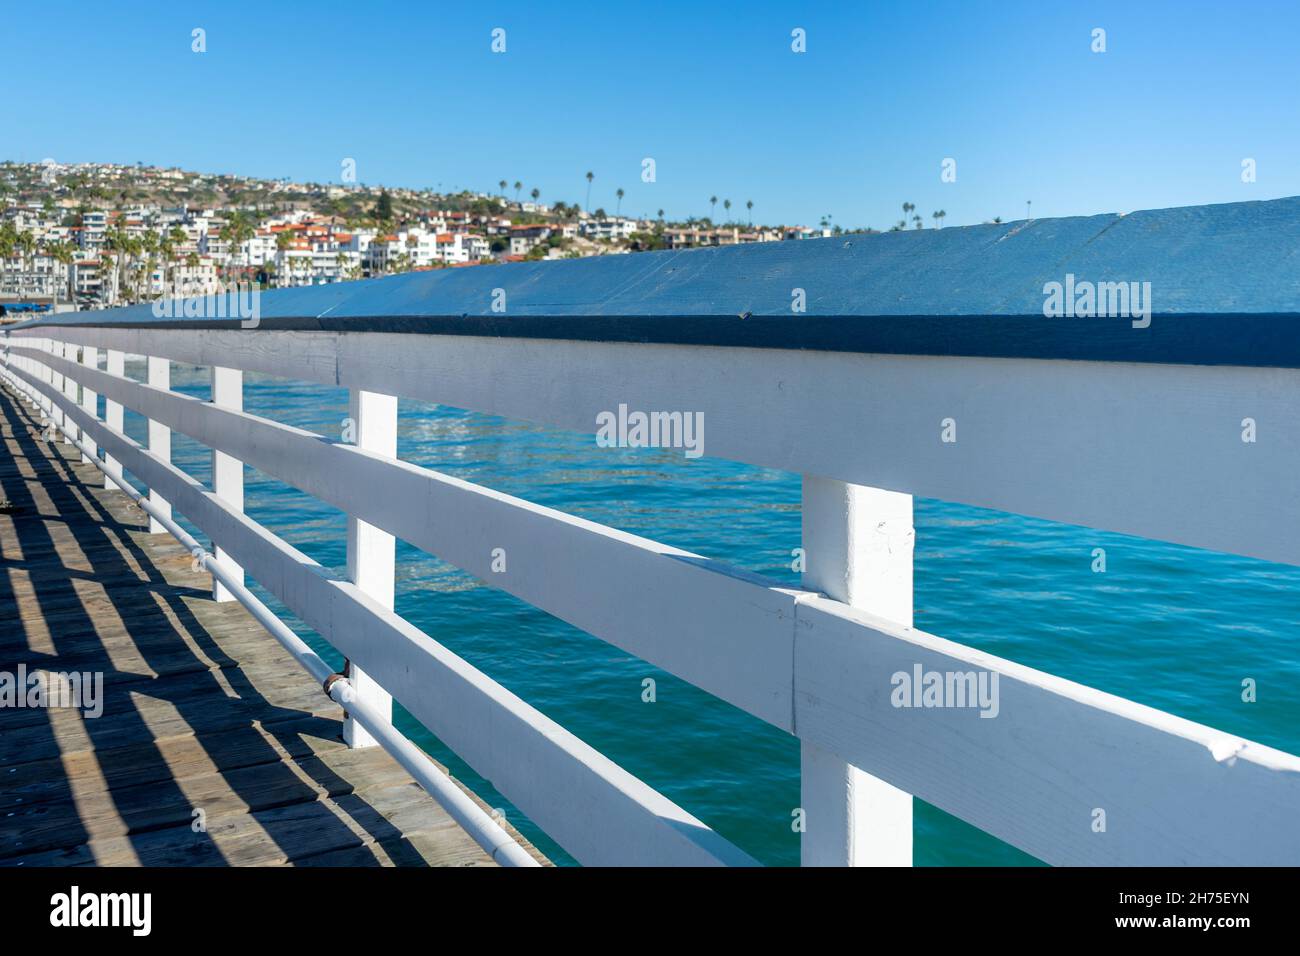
[14,196,1300,368]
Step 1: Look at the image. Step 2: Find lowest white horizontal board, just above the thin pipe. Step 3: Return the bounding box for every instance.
[0,363,754,866]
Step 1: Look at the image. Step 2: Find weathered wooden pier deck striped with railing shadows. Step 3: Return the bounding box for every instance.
[0,388,542,866]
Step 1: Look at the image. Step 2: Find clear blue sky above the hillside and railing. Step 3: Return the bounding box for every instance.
[0,0,1300,229]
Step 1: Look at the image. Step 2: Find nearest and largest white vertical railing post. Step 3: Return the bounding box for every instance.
[800,475,915,866]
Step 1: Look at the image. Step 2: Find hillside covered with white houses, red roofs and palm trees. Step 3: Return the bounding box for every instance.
[0,160,842,311]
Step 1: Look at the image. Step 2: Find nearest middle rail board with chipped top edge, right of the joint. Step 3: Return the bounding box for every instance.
[794,597,1300,866]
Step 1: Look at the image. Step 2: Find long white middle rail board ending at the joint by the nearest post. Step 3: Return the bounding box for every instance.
[16,350,801,732]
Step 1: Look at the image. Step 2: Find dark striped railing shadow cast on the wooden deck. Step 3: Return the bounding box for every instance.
[0,389,420,865]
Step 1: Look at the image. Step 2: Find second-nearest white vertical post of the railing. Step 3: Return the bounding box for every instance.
[343,389,398,748]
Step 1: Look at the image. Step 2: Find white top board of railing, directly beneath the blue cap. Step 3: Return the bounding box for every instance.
[14,326,1300,564]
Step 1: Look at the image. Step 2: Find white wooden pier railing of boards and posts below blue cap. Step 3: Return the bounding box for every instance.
[3,323,1300,865]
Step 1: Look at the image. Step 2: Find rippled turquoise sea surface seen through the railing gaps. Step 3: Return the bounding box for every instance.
[127,362,1300,865]
